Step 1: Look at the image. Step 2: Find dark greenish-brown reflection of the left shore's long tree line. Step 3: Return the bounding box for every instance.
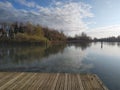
[0,45,65,64]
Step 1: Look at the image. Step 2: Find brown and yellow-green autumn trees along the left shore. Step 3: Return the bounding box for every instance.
[0,22,66,43]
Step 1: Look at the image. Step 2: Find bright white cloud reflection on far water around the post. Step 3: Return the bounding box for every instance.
[87,42,120,57]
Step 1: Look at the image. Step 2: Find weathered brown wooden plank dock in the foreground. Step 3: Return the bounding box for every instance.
[0,72,108,90]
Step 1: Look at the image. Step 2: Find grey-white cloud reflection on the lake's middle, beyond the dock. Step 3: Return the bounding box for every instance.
[37,46,93,73]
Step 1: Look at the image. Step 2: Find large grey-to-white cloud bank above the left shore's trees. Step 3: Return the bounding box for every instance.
[0,0,93,35]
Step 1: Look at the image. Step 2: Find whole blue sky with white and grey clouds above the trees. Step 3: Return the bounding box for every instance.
[0,0,120,38]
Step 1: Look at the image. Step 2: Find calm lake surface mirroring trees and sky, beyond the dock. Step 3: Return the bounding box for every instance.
[0,43,120,90]
